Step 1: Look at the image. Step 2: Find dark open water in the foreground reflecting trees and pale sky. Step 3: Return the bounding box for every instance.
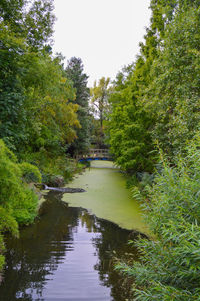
[0,192,137,301]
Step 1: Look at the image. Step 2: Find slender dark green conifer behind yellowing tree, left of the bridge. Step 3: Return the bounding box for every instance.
[65,57,91,155]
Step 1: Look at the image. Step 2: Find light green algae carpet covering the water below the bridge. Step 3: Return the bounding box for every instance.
[62,161,148,234]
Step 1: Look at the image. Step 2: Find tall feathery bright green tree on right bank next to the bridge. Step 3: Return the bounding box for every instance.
[109,9,160,173]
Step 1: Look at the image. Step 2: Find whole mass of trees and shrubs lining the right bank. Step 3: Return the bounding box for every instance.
[105,0,200,301]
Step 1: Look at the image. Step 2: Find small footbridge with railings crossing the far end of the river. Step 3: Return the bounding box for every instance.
[75,148,112,161]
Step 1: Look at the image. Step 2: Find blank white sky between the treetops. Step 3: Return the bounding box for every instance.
[53,0,150,86]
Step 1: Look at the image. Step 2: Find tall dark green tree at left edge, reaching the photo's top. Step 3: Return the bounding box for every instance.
[0,0,54,150]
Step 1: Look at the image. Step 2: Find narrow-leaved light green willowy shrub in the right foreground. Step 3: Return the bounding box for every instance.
[118,137,200,301]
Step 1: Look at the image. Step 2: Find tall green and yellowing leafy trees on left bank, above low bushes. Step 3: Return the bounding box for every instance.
[0,0,80,161]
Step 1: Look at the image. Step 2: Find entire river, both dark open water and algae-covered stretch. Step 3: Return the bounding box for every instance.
[0,161,146,301]
